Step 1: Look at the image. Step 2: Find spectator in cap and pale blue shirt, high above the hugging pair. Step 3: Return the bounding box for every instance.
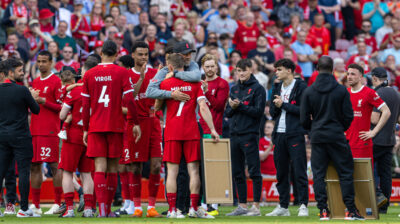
[207,4,238,38]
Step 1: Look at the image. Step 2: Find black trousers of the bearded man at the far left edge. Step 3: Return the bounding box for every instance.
[0,138,33,211]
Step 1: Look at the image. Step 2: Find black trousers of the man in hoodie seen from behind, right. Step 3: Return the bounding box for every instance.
[311,142,355,211]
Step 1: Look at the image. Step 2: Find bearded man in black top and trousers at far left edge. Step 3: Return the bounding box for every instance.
[0,59,40,217]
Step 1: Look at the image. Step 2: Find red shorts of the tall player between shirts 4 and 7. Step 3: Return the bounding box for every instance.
[128,117,162,162]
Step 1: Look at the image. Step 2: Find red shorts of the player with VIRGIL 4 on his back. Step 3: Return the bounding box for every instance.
[87,132,123,158]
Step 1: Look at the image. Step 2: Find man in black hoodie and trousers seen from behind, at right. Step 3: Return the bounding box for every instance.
[300,56,363,220]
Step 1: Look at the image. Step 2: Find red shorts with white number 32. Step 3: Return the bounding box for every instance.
[32,136,60,163]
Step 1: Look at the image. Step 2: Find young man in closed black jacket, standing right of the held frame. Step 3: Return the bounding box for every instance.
[226,59,266,216]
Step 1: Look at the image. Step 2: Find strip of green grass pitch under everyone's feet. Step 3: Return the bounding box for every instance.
[0,206,400,224]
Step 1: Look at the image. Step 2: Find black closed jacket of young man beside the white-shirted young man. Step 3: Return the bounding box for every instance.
[226,75,266,135]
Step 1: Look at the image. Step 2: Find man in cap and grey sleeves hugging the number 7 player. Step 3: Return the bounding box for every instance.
[146,41,201,102]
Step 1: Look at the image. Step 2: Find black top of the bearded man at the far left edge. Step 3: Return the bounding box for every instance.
[0,83,40,141]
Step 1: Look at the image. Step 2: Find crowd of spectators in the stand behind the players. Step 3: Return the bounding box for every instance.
[0,0,400,217]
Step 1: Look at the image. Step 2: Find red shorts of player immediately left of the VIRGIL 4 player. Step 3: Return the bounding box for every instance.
[58,141,94,173]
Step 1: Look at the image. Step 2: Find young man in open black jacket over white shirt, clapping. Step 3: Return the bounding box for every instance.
[266,59,308,216]
